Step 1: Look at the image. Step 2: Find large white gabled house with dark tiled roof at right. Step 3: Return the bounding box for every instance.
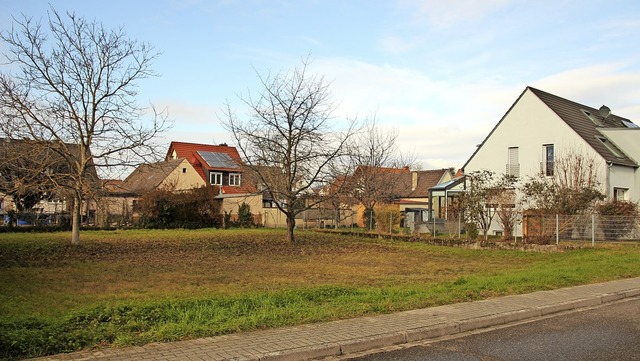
[462,87,640,235]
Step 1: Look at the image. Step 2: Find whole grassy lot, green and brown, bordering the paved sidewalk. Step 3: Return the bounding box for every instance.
[0,229,640,359]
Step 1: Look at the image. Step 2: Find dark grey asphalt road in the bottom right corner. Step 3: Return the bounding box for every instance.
[349,298,640,361]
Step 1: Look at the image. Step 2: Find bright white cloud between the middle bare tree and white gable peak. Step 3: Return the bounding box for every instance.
[304,58,524,169]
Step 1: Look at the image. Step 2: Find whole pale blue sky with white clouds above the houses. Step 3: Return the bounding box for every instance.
[0,0,640,170]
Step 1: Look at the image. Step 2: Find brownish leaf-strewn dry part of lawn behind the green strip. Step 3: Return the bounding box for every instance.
[0,230,539,315]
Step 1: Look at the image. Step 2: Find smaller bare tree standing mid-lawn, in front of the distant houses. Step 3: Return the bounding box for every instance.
[222,61,356,242]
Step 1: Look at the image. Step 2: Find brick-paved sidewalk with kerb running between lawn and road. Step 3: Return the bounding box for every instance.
[33,278,640,361]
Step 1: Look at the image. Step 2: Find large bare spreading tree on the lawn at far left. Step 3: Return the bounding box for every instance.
[0,8,170,244]
